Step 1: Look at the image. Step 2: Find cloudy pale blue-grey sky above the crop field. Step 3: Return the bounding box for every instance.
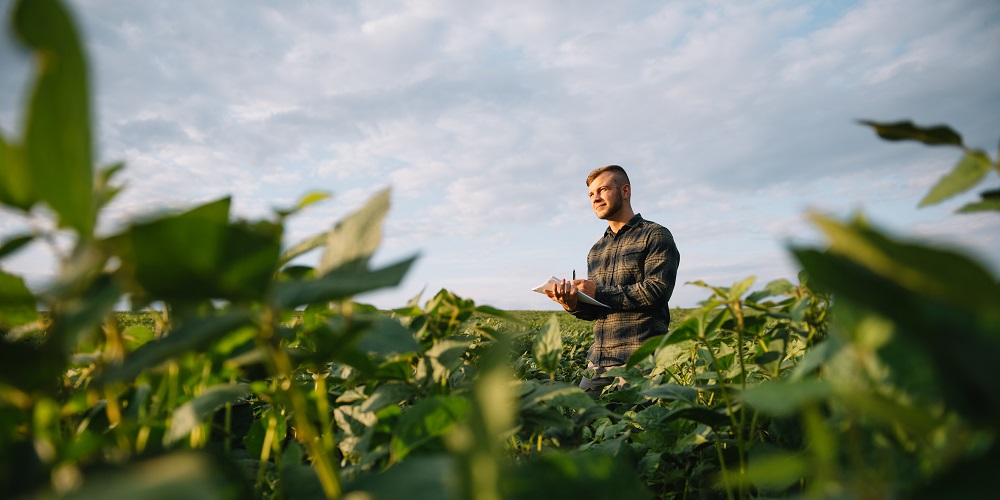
[0,0,1000,309]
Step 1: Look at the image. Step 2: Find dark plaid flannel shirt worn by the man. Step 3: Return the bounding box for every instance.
[572,214,681,367]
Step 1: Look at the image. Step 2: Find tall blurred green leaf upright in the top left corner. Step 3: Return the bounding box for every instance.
[14,0,95,239]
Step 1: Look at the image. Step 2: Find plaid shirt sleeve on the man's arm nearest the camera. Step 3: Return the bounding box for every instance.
[595,227,680,311]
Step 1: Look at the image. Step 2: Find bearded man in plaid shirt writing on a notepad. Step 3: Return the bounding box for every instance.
[546,165,681,395]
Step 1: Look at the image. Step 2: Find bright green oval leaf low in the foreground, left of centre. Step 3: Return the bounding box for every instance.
[390,396,472,461]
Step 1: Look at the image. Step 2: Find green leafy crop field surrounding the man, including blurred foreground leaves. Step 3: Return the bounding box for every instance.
[0,1,1000,500]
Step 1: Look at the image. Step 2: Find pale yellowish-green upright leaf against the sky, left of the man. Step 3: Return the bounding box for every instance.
[316,189,389,274]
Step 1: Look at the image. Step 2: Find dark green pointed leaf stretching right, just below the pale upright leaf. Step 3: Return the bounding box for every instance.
[275,256,417,309]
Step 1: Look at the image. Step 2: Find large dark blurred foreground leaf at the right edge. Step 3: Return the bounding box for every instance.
[794,235,1000,426]
